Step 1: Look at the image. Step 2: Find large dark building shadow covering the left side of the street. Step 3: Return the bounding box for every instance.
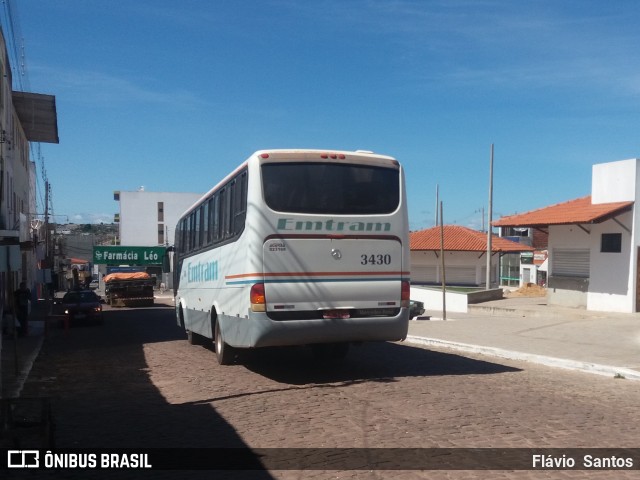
[22,307,272,479]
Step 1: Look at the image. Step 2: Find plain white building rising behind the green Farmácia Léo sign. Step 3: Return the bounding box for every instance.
[113,189,202,247]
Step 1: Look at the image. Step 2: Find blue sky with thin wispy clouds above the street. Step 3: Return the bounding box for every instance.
[3,0,640,230]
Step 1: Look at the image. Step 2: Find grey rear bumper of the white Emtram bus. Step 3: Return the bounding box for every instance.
[220,308,409,348]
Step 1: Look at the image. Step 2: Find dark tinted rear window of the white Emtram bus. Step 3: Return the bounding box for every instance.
[262,162,400,215]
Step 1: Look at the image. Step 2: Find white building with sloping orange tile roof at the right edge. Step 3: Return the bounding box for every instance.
[493,159,640,313]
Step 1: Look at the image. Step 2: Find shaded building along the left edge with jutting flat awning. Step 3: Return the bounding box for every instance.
[0,30,59,304]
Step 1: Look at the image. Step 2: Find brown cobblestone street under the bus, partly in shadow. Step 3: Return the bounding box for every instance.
[12,306,640,479]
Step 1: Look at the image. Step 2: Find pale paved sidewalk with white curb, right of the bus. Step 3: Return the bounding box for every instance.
[406,297,640,380]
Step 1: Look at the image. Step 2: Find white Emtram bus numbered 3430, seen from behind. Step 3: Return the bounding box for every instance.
[174,150,410,364]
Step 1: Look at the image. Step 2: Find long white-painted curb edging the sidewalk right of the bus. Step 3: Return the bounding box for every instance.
[405,335,640,380]
